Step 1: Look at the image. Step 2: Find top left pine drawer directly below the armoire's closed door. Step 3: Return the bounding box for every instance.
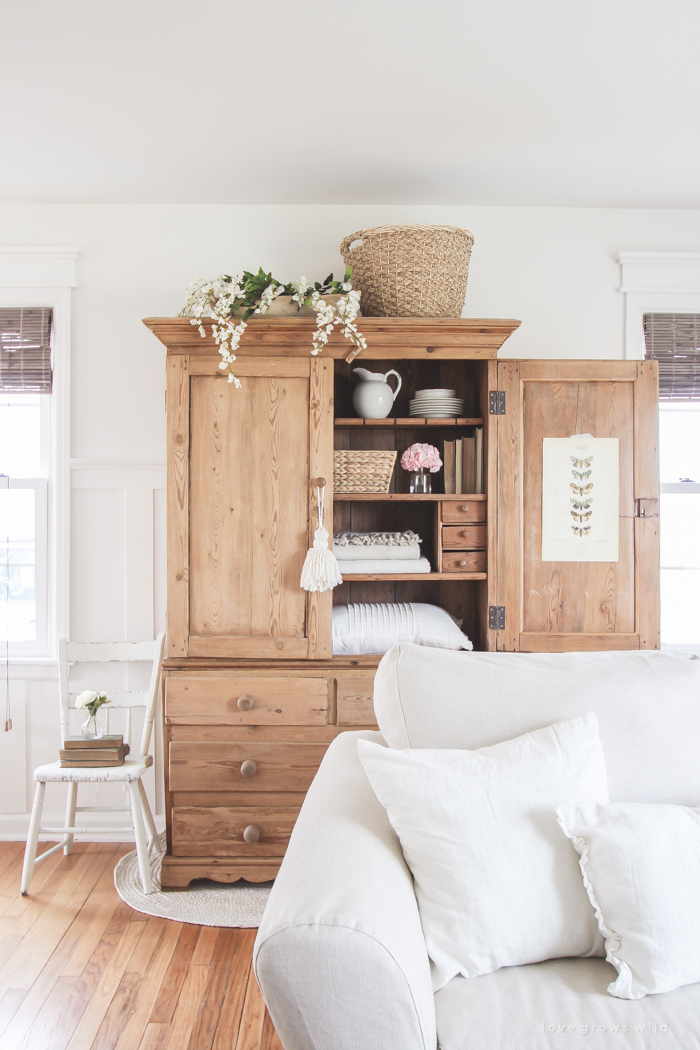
[165,675,328,726]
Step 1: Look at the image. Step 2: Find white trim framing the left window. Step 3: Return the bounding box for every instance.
[0,248,80,664]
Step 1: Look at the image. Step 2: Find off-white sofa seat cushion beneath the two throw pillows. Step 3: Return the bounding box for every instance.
[434,959,700,1050]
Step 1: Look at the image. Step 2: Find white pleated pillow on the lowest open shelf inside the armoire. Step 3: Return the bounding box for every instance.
[333,602,471,656]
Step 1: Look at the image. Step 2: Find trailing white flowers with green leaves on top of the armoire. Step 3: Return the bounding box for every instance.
[178,267,367,389]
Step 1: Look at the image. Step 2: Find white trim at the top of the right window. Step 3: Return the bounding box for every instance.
[617,252,700,360]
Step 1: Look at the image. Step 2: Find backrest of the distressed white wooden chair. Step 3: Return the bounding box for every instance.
[59,634,165,755]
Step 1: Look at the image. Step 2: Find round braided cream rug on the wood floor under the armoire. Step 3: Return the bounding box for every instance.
[114,835,272,927]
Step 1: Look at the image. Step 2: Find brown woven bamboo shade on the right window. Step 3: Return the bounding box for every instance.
[644,314,700,401]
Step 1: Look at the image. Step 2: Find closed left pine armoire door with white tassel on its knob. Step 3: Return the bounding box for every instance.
[168,355,333,659]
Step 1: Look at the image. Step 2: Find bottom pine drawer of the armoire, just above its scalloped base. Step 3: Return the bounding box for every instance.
[172,805,299,857]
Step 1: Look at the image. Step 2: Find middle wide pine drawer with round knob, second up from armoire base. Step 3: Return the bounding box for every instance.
[169,740,328,789]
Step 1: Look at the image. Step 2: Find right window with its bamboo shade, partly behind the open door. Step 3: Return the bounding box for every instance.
[644,314,700,647]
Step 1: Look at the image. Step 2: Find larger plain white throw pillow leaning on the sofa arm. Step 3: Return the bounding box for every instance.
[357,714,608,991]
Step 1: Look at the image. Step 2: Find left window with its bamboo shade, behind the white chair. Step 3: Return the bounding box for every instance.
[0,308,51,655]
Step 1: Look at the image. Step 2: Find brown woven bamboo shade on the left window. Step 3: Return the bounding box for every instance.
[0,307,52,394]
